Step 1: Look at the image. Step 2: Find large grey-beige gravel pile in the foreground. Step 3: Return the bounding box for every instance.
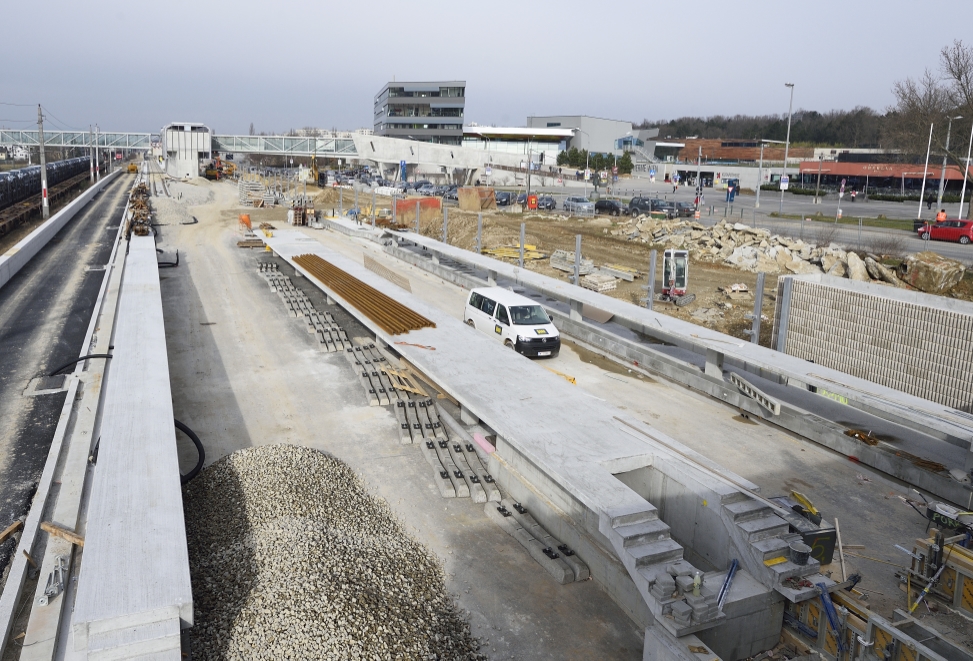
[183,445,486,660]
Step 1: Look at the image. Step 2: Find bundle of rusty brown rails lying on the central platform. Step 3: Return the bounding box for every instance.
[294,255,436,335]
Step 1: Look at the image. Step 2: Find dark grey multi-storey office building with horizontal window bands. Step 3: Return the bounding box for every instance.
[374,80,466,146]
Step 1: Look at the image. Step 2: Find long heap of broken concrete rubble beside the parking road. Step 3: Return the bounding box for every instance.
[611,215,963,293]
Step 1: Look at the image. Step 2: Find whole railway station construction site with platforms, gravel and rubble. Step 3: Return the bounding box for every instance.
[0,152,973,661]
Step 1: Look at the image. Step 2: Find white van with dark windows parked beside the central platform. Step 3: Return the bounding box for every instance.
[463,287,561,357]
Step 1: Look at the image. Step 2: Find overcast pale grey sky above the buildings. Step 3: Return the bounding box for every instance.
[0,0,973,133]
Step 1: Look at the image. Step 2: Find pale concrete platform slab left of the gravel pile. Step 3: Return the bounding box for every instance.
[71,236,193,658]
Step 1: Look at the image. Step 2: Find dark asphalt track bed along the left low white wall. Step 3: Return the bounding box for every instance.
[0,175,131,573]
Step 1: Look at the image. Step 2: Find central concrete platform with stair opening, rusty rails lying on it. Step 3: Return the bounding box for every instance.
[265,230,824,653]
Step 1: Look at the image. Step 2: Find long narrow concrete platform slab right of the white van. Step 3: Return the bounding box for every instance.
[393,228,973,451]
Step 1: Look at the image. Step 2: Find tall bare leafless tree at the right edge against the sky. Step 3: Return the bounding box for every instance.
[886,39,973,219]
